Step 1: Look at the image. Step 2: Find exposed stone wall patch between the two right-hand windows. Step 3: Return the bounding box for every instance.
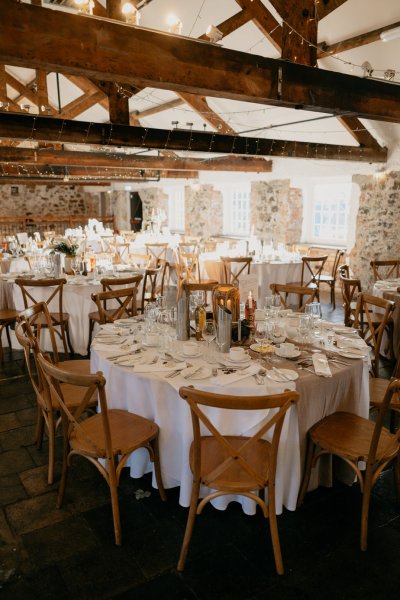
[250,179,303,244]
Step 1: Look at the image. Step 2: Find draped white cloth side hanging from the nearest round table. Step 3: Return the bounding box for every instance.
[91,348,369,514]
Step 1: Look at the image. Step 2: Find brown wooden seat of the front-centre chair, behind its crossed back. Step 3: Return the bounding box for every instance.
[189,436,271,493]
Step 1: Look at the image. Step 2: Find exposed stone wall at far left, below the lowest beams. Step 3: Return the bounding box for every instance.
[0,185,100,217]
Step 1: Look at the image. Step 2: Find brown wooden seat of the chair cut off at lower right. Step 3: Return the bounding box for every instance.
[310,412,397,462]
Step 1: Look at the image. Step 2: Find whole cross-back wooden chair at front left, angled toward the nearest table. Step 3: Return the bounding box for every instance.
[38,354,166,545]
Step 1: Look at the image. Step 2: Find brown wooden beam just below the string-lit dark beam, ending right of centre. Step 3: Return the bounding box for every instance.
[0,147,272,173]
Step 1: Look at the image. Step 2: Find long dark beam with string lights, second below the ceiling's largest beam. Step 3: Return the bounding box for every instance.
[0,113,387,162]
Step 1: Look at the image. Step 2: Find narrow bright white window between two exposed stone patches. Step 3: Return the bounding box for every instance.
[221,184,250,236]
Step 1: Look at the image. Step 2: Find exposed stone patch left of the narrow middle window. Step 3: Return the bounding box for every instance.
[185,185,223,240]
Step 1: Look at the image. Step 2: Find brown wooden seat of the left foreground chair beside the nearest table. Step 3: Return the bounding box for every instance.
[70,409,159,458]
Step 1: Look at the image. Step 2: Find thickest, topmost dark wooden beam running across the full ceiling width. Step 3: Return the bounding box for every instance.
[0,0,400,122]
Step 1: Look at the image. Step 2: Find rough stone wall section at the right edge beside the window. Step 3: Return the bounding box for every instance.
[350,171,400,291]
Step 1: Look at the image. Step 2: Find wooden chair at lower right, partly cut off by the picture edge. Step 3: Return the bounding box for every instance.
[298,379,400,550]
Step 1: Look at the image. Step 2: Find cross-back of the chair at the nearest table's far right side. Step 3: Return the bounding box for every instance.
[353,292,396,377]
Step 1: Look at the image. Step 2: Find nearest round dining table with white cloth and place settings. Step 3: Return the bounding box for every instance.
[91,332,369,514]
